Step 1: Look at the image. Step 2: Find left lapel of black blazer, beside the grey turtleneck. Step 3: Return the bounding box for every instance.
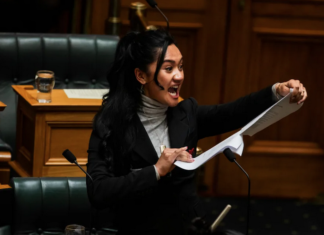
[134,114,158,165]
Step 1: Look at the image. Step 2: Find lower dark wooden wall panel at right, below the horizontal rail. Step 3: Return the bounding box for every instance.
[217,153,324,198]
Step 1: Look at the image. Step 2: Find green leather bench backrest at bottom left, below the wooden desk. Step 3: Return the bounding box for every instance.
[0,177,116,235]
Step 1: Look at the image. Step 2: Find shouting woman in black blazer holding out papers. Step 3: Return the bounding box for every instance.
[87,30,307,235]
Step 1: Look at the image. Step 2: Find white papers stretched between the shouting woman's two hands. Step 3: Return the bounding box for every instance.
[174,93,302,170]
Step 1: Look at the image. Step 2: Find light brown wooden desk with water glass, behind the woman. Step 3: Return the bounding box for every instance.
[9,85,102,177]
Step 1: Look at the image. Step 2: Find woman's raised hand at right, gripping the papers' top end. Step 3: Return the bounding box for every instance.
[276,79,307,104]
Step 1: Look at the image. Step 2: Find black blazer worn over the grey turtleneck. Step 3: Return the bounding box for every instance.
[87,87,273,235]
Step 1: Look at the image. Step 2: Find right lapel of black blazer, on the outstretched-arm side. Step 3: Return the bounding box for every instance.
[168,106,189,148]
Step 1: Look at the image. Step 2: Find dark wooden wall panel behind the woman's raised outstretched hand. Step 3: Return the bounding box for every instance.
[250,34,324,143]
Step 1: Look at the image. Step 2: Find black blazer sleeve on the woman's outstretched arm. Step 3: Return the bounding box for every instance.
[194,86,274,139]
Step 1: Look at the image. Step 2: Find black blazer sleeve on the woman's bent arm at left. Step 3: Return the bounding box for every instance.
[87,131,158,209]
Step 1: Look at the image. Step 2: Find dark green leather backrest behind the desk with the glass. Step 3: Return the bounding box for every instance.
[0,33,119,154]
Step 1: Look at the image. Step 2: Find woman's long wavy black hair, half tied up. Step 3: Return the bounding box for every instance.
[94,30,175,175]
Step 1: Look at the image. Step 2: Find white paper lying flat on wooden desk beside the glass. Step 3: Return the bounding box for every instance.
[64,89,109,99]
